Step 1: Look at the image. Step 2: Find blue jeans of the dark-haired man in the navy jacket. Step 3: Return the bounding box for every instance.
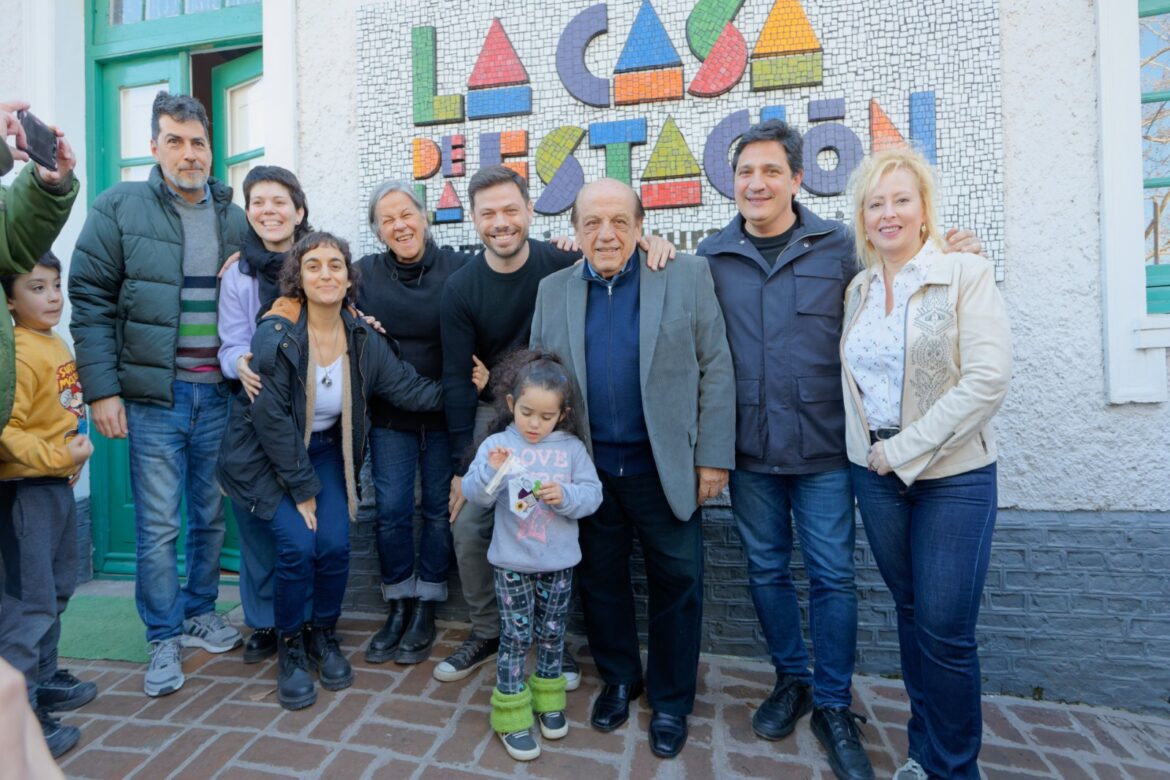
[731,469,858,706]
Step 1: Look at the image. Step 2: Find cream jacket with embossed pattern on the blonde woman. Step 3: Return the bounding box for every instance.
[841,242,1012,485]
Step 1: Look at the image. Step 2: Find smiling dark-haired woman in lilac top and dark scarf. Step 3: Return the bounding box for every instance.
[218,165,312,663]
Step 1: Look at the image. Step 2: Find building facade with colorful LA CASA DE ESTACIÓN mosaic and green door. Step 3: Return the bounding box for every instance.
[0,0,1170,711]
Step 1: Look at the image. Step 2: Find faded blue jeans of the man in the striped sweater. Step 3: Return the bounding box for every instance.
[125,380,228,642]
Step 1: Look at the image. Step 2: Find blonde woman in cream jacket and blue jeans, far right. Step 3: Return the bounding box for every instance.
[841,149,1011,780]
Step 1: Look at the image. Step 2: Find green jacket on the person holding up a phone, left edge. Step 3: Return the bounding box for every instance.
[0,166,81,429]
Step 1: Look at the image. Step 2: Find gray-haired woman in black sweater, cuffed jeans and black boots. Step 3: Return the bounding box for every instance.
[357,180,487,664]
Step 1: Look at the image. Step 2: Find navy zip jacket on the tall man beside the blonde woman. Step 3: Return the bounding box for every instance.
[698,201,858,474]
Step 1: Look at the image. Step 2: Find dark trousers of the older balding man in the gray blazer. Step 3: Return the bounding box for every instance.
[577,471,703,715]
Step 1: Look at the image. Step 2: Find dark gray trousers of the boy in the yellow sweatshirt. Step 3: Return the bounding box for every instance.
[0,478,77,692]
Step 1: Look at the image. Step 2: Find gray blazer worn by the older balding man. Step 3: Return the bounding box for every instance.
[531,250,735,520]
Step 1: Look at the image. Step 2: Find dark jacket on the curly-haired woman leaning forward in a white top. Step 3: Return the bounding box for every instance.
[215,298,442,520]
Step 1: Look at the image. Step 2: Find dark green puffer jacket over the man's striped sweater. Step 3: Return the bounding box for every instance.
[69,165,250,406]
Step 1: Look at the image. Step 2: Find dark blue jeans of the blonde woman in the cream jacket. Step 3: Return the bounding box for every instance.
[853,463,997,779]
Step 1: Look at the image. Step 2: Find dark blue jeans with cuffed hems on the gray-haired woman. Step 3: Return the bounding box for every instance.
[370,428,453,601]
